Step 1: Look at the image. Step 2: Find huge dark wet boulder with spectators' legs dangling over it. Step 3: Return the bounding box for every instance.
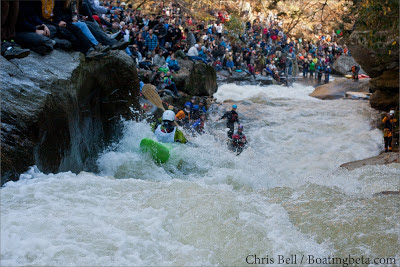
[1,50,139,184]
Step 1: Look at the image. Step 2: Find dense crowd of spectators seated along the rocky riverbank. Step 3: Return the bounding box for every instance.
[2,0,347,86]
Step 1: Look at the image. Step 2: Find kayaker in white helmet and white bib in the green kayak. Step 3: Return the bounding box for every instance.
[153,110,187,143]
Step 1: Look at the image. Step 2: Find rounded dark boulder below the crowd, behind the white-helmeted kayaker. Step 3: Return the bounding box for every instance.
[173,59,218,96]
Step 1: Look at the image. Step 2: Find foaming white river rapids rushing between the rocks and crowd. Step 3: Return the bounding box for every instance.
[1,84,400,266]
